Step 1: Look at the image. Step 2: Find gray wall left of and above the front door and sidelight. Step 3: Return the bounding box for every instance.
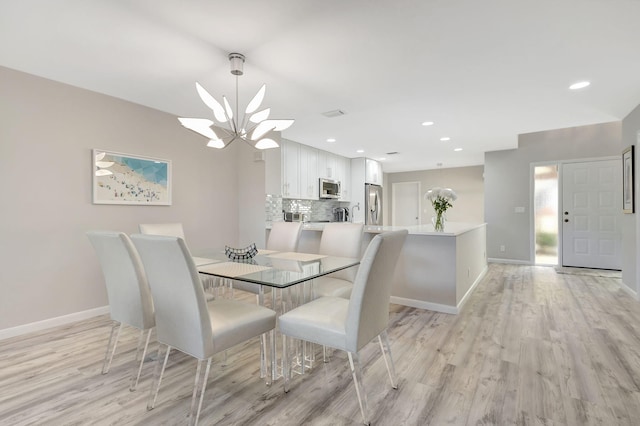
[484,121,622,262]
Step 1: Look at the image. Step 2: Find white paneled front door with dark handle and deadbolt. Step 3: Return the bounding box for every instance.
[561,160,622,269]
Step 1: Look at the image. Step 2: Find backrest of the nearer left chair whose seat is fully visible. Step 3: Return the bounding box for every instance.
[131,234,214,359]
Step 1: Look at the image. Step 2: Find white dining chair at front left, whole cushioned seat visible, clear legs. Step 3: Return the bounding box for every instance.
[131,234,276,424]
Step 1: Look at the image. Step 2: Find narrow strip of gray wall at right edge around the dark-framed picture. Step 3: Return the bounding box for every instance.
[620,105,640,293]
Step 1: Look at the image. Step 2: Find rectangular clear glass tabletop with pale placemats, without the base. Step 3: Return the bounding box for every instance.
[193,250,360,288]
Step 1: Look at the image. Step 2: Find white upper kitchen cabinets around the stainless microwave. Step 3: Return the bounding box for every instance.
[265,139,351,201]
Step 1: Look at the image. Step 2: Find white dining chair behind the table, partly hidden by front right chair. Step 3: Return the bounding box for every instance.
[313,222,364,299]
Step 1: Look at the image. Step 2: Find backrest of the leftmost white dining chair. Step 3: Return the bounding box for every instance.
[87,231,155,330]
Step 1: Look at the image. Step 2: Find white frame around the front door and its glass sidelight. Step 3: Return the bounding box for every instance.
[529,155,620,266]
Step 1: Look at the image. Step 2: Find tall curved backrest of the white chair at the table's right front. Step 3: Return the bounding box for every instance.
[346,230,408,352]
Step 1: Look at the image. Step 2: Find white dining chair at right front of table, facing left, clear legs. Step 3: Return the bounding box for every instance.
[279,230,408,424]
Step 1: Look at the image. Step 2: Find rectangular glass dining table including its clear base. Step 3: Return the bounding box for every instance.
[193,250,360,380]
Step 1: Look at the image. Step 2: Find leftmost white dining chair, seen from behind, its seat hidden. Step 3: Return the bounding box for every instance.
[87,231,155,391]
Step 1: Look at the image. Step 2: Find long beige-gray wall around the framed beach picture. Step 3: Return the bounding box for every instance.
[0,67,250,330]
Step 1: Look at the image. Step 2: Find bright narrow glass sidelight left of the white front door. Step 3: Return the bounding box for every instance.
[533,164,559,265]
